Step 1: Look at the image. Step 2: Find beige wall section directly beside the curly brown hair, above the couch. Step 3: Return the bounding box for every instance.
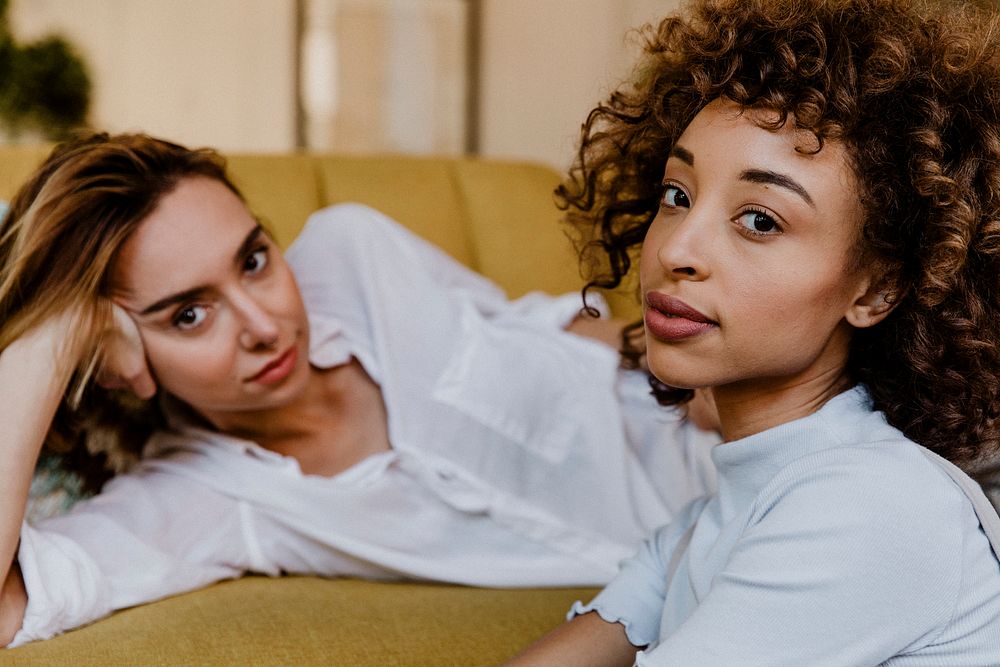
[479,0,678,169]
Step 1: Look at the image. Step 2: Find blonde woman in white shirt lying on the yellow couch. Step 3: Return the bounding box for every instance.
[0,134,712,645]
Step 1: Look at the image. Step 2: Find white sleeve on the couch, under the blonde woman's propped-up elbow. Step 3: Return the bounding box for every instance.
[10,464,252,647]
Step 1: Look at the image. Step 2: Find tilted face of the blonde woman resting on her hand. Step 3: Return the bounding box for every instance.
[112,177,309,420]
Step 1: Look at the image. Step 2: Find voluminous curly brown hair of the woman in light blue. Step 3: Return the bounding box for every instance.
[556,0,1000,468]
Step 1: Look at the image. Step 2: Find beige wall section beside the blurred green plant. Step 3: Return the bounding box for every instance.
[10,0,295,151]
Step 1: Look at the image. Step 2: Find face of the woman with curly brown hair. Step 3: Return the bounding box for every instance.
[640,100,870,392]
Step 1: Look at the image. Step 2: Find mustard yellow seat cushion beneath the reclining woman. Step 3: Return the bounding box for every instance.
[3,577,595,667]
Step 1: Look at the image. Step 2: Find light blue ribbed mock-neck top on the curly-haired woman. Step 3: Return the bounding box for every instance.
[574,388,1000,667]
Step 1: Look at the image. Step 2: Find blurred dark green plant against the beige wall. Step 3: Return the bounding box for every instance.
[0,0,91,140]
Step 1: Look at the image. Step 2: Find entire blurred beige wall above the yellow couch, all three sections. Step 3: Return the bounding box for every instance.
[5,0,677,162]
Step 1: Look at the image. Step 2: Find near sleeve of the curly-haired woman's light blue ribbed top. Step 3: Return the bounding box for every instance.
[636,450,965,667]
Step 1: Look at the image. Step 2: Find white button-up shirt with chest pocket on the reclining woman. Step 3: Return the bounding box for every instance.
[13,205,716,645]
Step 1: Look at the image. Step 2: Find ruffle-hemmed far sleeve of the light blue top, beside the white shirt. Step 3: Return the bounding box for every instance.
[567,498,707,646]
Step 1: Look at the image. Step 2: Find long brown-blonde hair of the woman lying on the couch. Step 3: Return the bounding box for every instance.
[0,133,242,490]
